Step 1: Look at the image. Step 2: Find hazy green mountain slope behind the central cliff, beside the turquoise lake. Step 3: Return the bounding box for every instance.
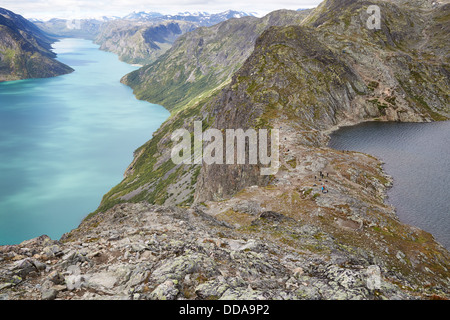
[122,10,308,111]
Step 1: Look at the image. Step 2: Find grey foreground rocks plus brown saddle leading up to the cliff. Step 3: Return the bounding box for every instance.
[0,117,450,300]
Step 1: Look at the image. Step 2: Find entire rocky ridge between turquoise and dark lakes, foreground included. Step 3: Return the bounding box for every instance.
[0,0,450,300]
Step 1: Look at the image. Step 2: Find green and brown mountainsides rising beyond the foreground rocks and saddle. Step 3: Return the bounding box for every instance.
[99,1,450,214]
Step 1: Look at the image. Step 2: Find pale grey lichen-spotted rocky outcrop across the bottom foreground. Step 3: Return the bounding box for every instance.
[0,203,449,300]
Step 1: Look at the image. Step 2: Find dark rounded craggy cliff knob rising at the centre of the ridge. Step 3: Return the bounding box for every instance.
[196,26,365,202]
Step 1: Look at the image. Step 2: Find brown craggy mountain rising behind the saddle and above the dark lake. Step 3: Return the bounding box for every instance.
[196,1,450,201]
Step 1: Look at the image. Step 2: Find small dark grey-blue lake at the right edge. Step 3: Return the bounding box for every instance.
[329,122,450,249]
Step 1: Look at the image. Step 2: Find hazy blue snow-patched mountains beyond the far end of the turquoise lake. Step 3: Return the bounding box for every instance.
[34,10,254,65]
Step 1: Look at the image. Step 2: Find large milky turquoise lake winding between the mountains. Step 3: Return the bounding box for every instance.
[0,39,169,245]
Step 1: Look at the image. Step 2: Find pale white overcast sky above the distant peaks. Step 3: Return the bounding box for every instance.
[0,0,322,19]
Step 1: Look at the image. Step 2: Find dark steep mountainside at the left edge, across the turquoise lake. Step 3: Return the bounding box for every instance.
[0,8,73,81]
